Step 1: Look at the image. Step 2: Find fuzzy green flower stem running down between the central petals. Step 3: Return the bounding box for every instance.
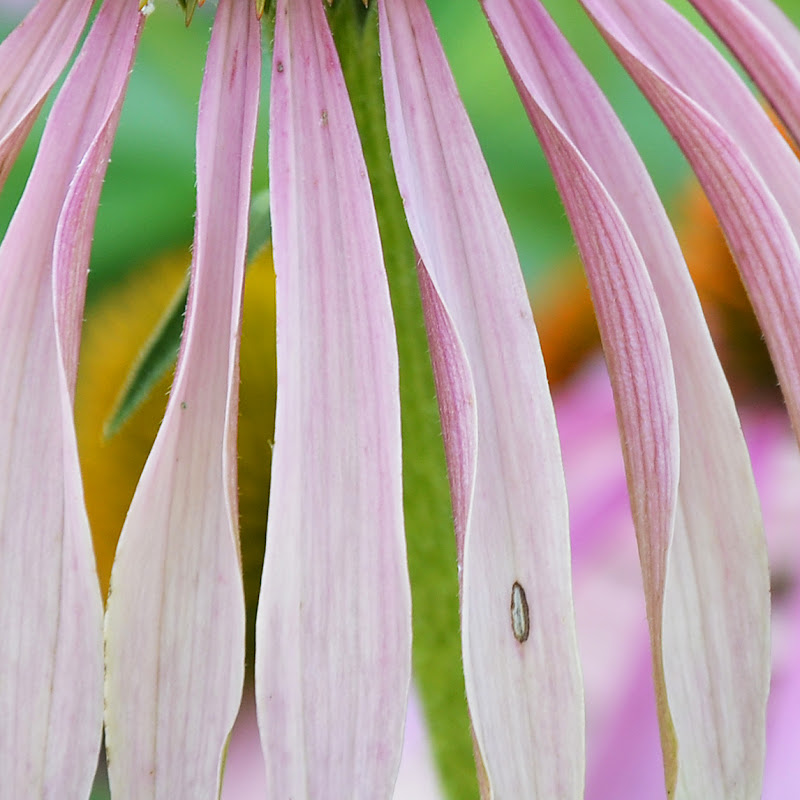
[330,0,479,800]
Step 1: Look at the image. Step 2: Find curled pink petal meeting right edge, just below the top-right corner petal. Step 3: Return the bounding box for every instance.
[582,0,800,446]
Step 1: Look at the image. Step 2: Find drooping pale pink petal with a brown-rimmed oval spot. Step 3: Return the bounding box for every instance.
[379,0,584,798]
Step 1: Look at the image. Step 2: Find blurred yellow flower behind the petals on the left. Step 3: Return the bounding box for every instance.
[75,248,276,652]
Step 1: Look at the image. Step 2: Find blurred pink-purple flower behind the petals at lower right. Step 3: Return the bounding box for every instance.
[555,362,800,800]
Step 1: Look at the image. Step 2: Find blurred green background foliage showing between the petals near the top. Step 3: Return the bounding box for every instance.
[0,0,800,300]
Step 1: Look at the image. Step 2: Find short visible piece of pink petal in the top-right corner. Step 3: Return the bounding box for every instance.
[692,0,800,141]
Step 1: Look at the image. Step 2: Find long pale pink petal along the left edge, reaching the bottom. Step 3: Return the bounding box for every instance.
[0,0,142,797]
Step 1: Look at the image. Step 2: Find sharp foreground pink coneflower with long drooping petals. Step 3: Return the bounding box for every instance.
[0,0,800,800]
